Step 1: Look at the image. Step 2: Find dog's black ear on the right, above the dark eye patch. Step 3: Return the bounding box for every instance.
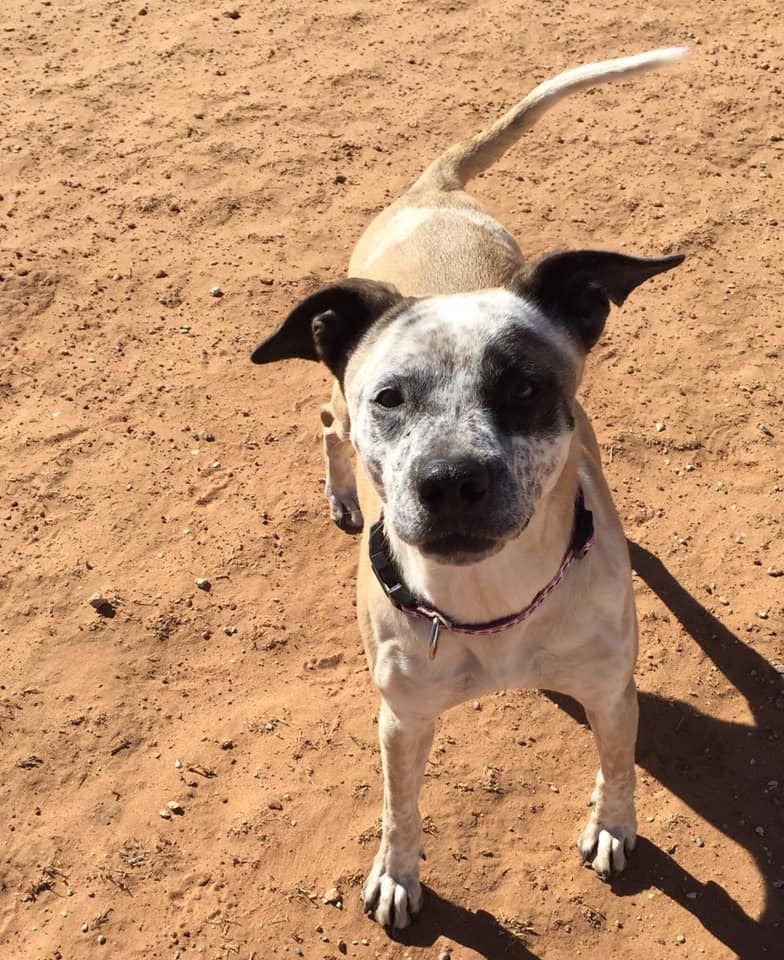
[513,250,684,350]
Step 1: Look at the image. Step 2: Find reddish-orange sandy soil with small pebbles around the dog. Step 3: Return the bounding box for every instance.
[0,0,784,960]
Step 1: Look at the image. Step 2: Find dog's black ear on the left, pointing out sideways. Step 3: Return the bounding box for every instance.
[250,279,403,380]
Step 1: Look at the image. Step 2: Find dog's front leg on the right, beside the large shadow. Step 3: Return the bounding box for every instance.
[577,681,638,880]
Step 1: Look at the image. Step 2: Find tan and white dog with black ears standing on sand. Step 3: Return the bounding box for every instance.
[251,48,686,932]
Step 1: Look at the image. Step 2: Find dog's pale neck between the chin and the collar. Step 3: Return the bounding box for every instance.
[387,441,578,623]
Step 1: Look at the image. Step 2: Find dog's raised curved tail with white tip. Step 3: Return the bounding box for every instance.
[414,47,689,190]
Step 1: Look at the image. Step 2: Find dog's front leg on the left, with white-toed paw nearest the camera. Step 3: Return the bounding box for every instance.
[362,699,435,930]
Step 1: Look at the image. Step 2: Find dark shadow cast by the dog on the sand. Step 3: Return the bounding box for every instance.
[401,541,784,960]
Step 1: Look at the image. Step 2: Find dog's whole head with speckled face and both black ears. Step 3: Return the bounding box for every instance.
[252,251,683,564]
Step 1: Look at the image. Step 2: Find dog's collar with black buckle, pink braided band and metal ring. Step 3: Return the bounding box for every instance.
[369,487,595,660]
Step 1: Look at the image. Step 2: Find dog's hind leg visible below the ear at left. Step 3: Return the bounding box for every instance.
[321,380,363,533]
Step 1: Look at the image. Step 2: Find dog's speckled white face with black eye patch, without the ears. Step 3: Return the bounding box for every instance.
[346,290,582,563]
